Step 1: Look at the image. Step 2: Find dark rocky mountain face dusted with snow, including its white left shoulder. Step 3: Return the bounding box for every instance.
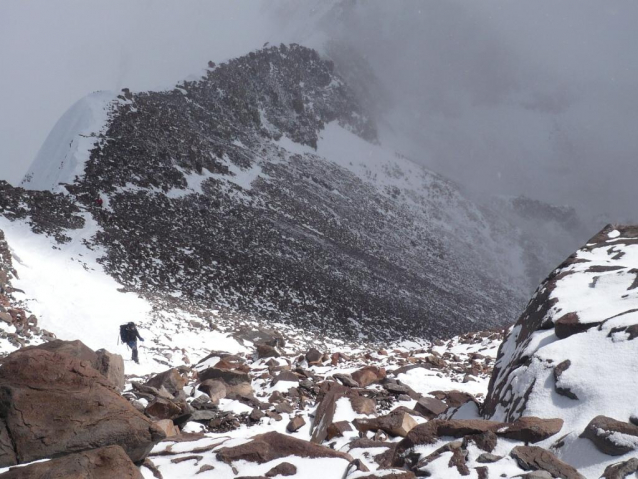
[10,45,592,340]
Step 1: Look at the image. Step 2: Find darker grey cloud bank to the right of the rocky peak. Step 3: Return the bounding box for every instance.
[288,0,638,220]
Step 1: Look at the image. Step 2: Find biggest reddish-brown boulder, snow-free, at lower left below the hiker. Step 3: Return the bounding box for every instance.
[0,348,165,466]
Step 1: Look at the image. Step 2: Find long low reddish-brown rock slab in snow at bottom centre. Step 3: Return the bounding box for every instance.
[217,432,352,464]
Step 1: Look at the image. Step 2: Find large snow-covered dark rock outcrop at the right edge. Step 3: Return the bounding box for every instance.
[484,226,638,477]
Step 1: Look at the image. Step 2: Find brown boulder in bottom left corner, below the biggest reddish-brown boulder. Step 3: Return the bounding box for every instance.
[0,446,143,479]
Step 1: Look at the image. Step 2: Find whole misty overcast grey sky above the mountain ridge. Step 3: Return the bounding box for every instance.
[0,0,638,219]
